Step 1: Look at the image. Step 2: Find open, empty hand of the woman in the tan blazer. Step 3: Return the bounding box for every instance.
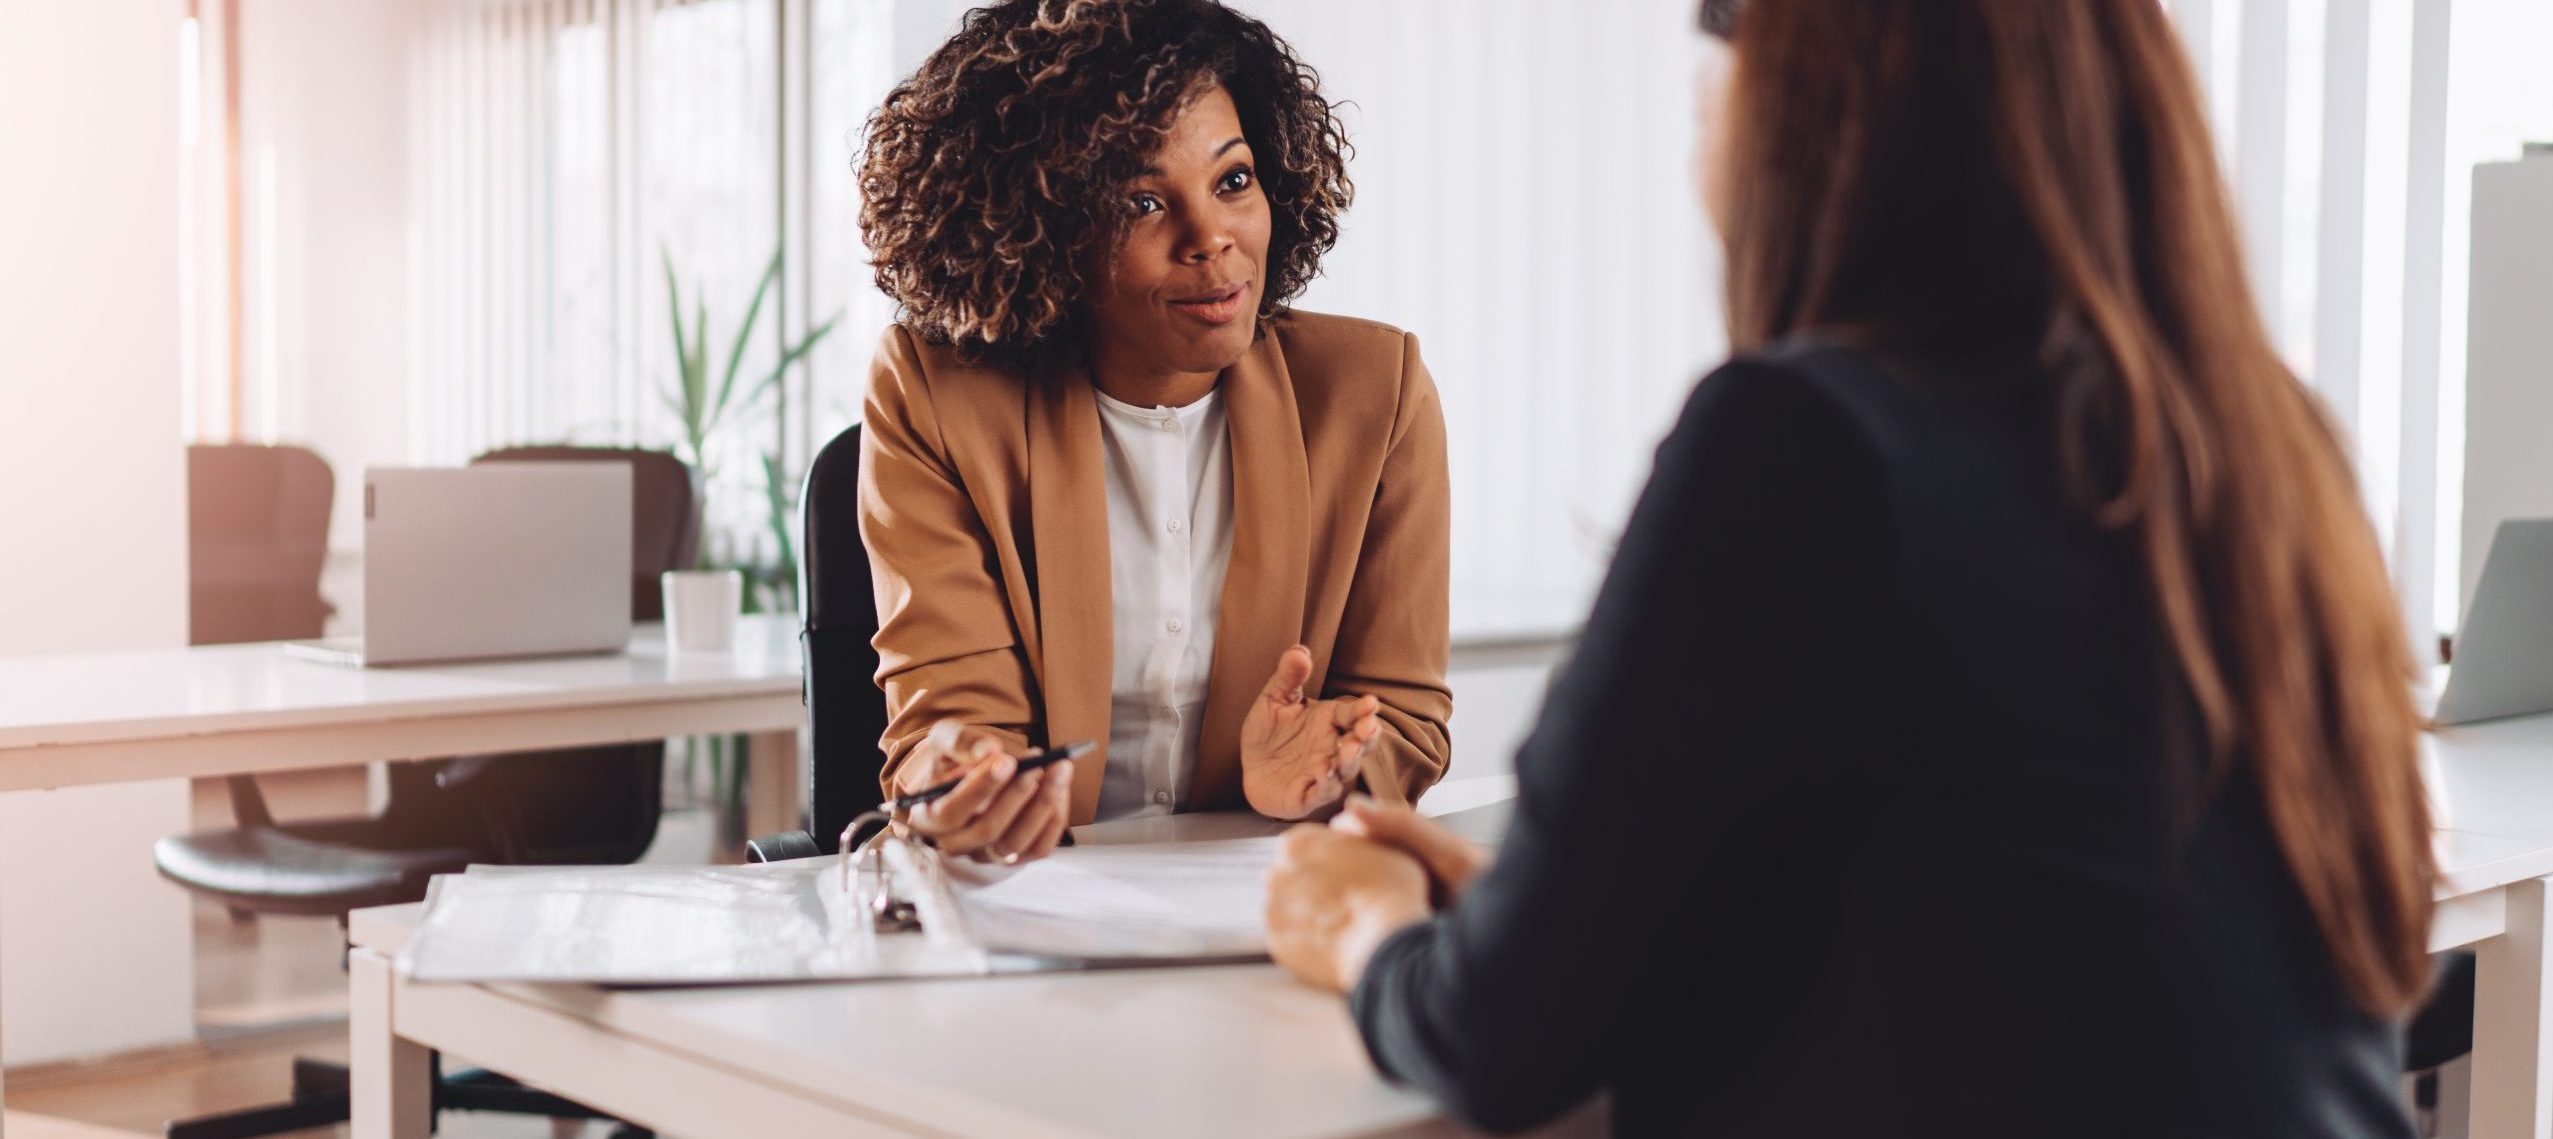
[1241,644,1384,820]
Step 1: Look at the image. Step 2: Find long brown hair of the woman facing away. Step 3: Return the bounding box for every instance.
[1703,0,2436,1014]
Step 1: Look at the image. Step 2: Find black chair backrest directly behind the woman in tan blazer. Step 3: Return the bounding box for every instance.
[799,424,886,853]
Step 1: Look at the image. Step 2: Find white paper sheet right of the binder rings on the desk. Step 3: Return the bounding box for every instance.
[947,838,1277,965]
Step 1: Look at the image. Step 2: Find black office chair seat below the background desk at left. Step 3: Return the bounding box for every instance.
[151,827,472,917]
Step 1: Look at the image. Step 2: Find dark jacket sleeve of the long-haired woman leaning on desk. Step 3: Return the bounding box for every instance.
[1351,363,1887,1131]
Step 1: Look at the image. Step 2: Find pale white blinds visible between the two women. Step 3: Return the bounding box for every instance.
[1238,0,1726,636]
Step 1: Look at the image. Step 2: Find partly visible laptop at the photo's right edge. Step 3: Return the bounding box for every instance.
[2438,518,2553,723]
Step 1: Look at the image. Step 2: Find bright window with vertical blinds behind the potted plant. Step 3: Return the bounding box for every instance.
[408,0,888,587]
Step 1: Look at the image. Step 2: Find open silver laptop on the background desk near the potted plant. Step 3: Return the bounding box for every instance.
[286,462,633,667]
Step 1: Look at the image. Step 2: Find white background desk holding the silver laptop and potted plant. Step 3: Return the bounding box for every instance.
[0,615,804,1128]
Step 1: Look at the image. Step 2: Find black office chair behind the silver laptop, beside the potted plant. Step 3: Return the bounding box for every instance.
[153,447,702,1139]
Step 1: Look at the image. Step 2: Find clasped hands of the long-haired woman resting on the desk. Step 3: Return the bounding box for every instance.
[1266,822,1427,993]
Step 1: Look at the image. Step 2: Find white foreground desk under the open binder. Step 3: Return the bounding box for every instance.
[350,779,1601,1139]
